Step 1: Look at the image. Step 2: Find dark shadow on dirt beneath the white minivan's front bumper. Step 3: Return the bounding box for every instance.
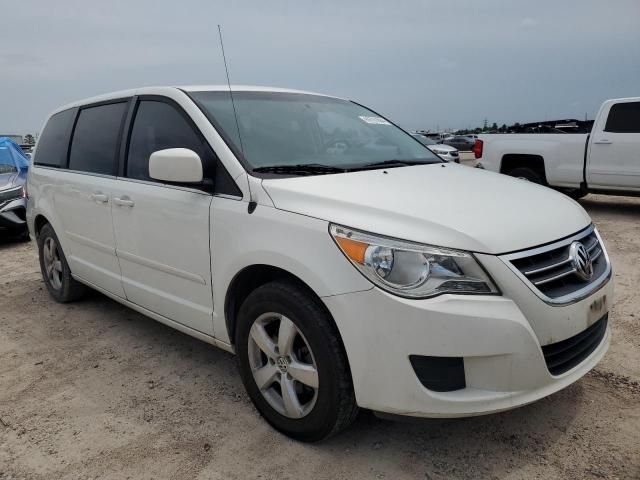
[320,392,583,478]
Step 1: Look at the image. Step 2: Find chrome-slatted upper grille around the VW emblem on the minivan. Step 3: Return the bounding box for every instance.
[502,226,611,304]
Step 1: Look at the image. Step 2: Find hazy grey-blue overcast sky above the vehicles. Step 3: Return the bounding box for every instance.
[0,0,640,134]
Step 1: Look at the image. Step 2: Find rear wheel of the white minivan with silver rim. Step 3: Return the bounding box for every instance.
[38,224,86,303]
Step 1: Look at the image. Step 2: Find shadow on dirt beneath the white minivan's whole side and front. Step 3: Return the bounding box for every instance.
[75,286,586,478]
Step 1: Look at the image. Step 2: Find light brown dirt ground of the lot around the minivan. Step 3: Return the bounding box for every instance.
[0,196,640,480]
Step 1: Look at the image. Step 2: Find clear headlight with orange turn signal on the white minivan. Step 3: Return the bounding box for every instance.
[330,225,499,298]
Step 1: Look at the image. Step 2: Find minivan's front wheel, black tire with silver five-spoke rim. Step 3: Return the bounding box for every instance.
[236,281,358,442]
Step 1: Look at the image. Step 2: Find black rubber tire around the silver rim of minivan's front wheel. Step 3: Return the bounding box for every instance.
[235,281,358,442]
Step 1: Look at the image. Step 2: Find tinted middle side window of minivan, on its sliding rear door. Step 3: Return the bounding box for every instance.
[69,102,127,175]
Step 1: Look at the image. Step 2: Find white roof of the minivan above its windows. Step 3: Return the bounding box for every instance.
[52,85,339,115]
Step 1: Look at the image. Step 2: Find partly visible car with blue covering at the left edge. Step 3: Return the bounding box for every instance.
[0,137,29,235]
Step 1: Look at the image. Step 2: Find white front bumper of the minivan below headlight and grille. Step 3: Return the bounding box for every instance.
[323,276,613,417]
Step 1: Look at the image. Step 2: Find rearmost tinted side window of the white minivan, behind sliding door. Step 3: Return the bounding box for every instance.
[33,109,76,167]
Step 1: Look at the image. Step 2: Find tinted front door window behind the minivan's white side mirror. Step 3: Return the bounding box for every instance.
[127,100,214,180]
